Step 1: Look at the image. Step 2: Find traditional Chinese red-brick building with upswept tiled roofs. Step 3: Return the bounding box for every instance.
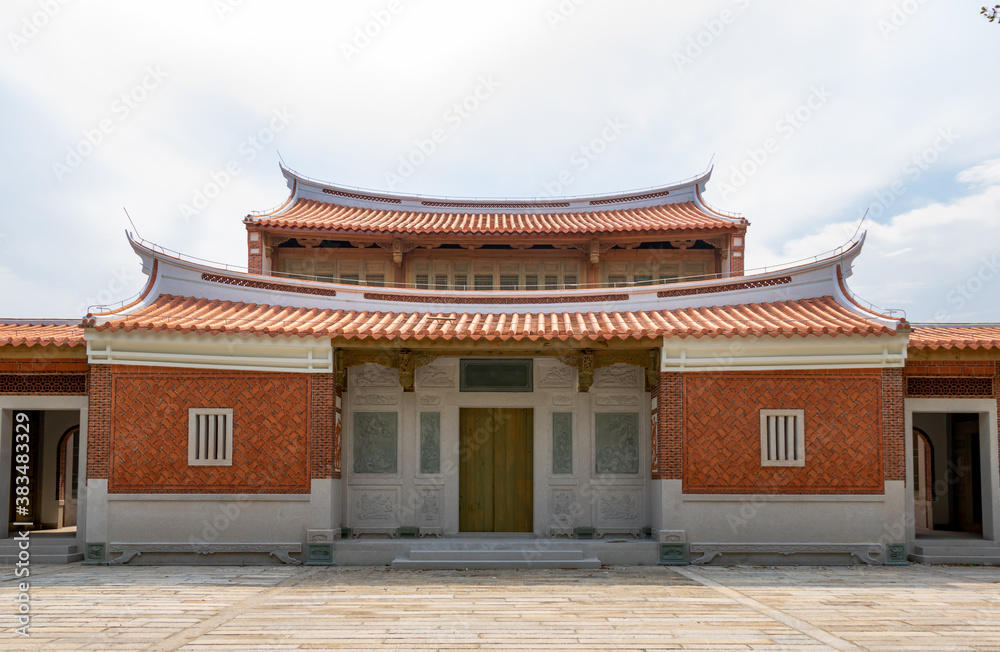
[0,164,1000,568]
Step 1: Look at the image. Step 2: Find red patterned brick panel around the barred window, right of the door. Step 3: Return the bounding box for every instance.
[678,370,884,494]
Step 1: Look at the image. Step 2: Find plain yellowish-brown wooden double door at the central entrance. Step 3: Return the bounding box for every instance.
[458,408,534,532]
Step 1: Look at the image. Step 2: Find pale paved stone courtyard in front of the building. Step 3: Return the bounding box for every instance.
[0,565,1000,652]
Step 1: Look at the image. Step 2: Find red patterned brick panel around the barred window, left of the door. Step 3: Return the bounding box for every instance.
[109,367,310,494]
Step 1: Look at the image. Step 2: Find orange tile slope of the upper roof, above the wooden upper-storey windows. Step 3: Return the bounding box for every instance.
[248,199,741,236]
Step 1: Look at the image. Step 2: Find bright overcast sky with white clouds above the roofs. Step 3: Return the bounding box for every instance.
[0,0,1000,321]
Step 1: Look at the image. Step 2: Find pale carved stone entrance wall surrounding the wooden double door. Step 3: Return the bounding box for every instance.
[341,357,651,536]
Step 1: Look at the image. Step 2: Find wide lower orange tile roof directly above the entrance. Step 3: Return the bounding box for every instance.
[97,295,895,341]
